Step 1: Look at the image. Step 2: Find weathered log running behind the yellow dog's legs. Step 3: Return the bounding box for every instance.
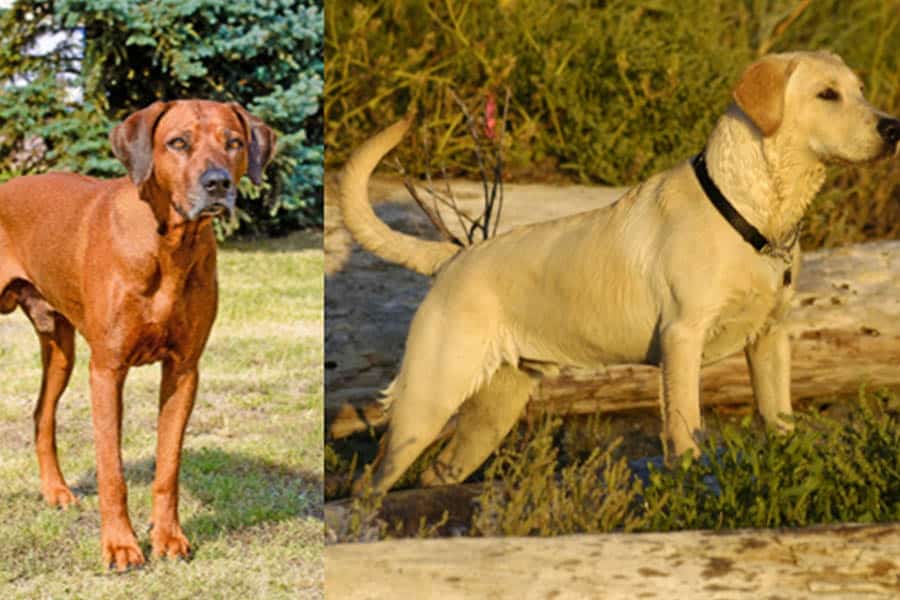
[326,240,900,438]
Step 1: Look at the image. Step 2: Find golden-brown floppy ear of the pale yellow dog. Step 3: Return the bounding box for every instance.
[732,56,796,137]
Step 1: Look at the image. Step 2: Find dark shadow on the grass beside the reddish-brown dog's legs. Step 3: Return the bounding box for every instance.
[74,448,324,543]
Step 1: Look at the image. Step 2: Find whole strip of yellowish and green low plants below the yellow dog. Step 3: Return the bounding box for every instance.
[473,395,900,535]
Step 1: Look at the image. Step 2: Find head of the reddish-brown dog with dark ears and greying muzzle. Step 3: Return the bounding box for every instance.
[110,100,275,221]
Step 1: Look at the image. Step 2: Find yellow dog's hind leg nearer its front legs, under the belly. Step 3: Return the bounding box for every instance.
[421,365,538,486]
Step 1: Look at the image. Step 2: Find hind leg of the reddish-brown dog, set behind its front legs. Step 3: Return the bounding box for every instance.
[15,281,75,508]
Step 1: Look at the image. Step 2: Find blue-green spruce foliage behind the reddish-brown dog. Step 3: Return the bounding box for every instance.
[0,0,324,233]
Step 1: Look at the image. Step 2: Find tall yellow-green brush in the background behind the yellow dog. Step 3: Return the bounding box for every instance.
[325,0,900,246]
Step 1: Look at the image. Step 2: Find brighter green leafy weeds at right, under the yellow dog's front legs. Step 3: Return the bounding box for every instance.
[644,398,900,531]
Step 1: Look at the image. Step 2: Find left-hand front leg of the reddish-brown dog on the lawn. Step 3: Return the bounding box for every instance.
[91,360,144,571]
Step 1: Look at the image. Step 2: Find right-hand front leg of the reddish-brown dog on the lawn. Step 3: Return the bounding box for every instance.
[150,359,198,558]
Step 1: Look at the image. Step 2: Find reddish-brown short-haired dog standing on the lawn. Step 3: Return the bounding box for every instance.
[0,100,275,570]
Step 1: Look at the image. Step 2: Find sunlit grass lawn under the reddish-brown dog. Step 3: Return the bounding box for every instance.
[0,233,324,599]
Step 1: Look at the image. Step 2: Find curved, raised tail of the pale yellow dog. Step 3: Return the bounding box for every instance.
[339,116,461,275]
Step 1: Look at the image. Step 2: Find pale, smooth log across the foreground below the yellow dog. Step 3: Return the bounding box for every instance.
[325,524,900,600]
